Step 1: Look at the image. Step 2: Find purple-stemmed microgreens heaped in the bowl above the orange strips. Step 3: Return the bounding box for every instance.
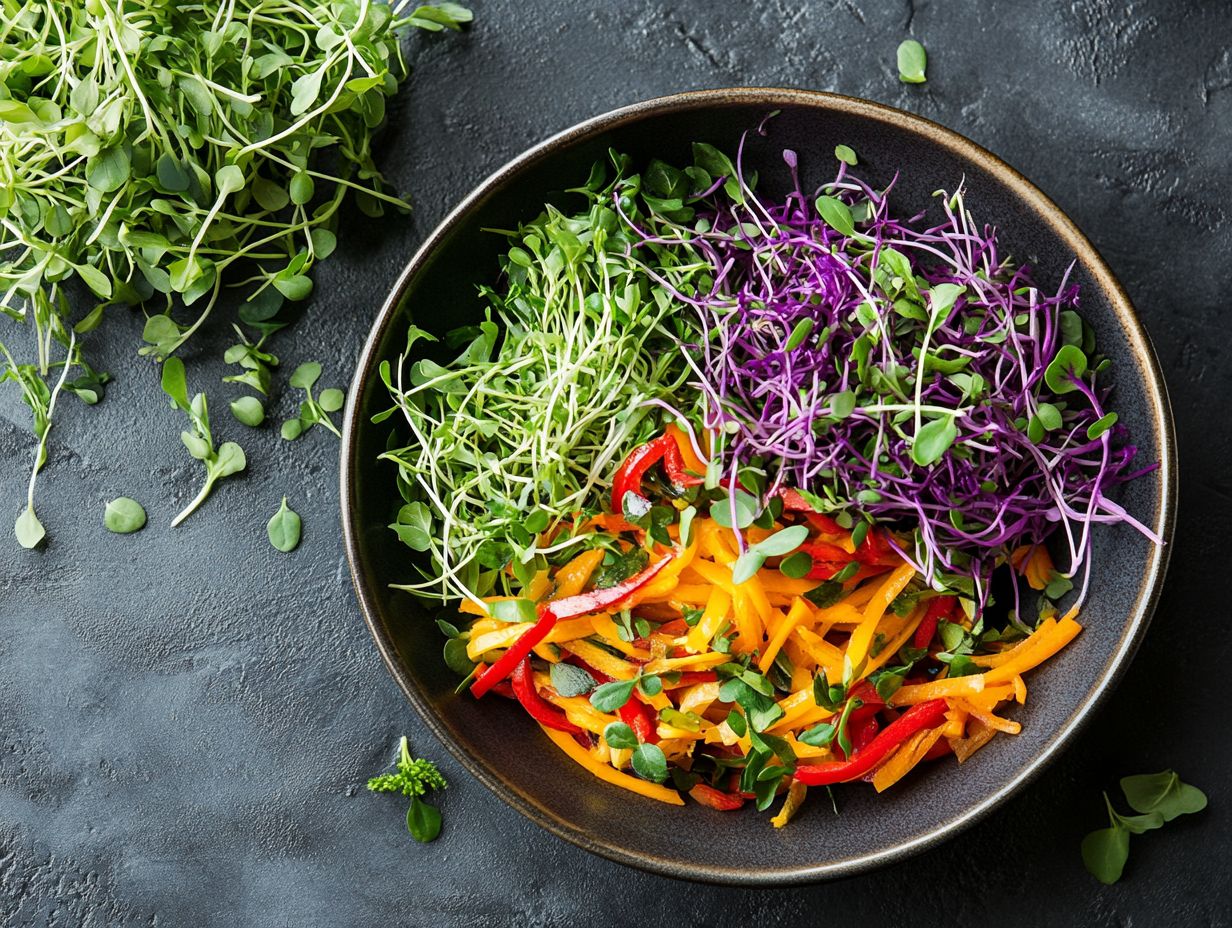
[665,142,1158,613]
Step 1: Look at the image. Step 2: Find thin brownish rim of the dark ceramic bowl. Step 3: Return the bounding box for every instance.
[340,88,1177,886]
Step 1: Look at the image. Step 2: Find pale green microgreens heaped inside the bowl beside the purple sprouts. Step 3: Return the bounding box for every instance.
[375,147,719,599]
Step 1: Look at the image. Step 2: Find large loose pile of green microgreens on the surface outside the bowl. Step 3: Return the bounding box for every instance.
[0,0,471,534]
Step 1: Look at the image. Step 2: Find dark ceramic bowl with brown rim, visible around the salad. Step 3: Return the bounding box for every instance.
[342,89,1177,885]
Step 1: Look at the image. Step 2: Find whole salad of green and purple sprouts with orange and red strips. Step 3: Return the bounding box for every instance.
[377,127,1159,826]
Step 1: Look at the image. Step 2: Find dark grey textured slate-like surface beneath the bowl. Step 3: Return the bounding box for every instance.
[0,0,1232,928]
